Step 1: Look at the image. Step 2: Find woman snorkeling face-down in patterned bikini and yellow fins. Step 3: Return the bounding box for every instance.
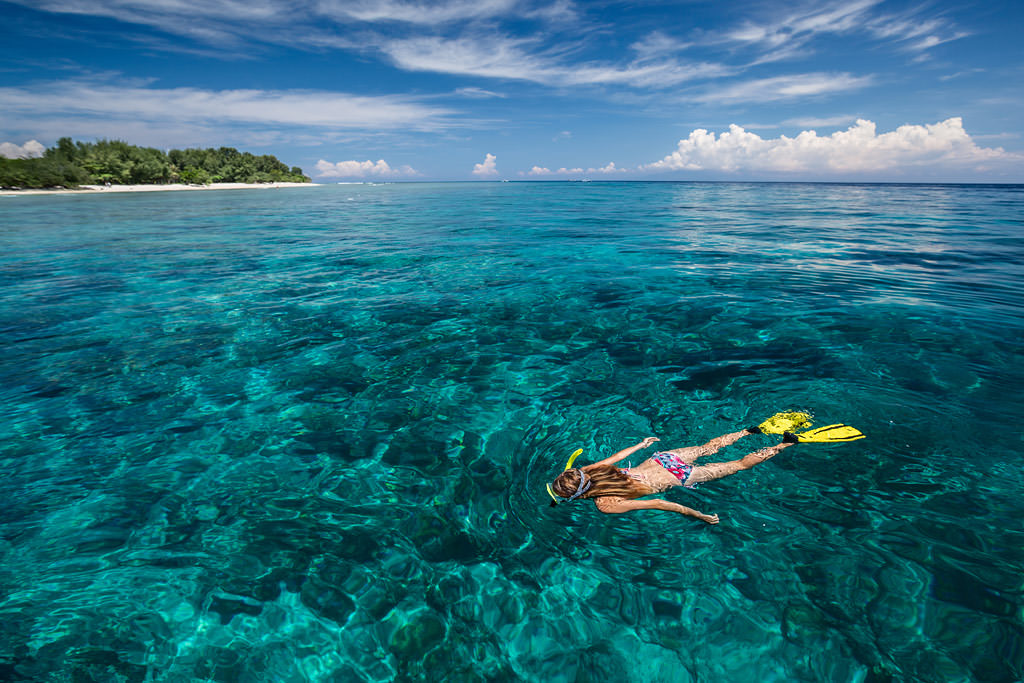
[548,413,864,524]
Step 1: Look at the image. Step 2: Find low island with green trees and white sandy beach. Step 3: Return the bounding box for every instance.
[0,137,309,189]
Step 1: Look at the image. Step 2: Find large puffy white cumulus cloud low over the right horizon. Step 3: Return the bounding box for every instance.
[643,118,1014,173]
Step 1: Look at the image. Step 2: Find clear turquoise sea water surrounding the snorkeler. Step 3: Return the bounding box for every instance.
[0,183,1024,681]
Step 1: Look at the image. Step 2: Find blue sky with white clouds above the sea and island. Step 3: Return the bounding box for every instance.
[0,0,1024,182]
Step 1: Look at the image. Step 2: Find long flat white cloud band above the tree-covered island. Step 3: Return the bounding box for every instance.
[0,80,454,139]
